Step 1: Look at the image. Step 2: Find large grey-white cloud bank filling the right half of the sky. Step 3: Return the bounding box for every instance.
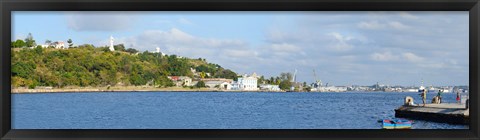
[251,12,468,85]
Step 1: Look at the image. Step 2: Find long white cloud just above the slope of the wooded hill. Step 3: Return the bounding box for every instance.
[94,28,259,72]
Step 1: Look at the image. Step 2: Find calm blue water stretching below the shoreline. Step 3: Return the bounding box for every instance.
[12,92,468,129]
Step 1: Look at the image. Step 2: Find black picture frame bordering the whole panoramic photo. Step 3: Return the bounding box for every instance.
[0,0,480,140]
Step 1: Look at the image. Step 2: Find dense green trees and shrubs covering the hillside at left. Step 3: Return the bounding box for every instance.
[11,44,236,88]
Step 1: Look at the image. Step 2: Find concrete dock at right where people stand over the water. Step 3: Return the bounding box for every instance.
[395,103,470,124]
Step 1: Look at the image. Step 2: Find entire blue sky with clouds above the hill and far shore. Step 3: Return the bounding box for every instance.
[12,11,469,86]
